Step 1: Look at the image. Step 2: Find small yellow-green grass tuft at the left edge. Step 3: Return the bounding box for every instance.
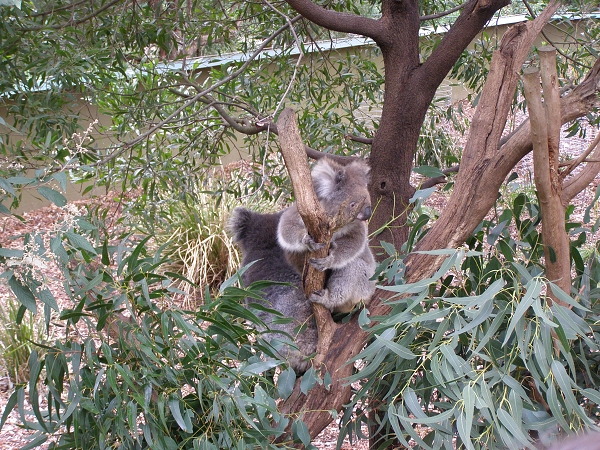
[0,298,45,384]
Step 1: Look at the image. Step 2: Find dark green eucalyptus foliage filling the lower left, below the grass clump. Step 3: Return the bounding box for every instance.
[2,214,310,449]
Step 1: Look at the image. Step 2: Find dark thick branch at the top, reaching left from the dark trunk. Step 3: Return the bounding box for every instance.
[286,0,383,42]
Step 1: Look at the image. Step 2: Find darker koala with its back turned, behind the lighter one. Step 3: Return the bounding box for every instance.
[228,207,318,374]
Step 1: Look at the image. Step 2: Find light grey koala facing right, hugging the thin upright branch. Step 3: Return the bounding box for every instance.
[277,158,375,313]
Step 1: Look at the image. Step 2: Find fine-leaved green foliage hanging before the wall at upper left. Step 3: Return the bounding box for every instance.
[0,0,383,212]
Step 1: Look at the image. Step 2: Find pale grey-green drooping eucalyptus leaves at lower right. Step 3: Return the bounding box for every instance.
[342,194,600,449]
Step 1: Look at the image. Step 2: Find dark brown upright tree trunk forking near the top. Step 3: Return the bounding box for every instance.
[369,0,509,253]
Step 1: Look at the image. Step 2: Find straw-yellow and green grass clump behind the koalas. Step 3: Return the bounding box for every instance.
[138,163,283,309]
